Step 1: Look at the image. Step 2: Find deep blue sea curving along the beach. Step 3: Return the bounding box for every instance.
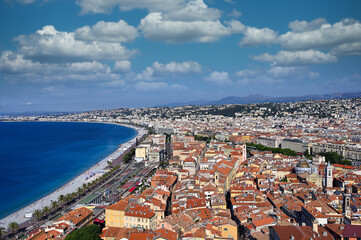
[0,122,137,219]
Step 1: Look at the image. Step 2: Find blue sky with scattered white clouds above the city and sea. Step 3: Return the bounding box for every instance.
[0,0,361,113]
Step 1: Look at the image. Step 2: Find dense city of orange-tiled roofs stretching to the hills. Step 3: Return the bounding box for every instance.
[3,98,361,240]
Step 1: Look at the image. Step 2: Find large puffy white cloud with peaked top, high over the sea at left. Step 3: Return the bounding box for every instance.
[16,26,137,62]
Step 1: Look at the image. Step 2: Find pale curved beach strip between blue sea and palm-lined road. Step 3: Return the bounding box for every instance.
[0,121,146,229]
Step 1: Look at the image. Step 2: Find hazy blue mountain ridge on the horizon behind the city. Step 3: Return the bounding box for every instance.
[158,91,361,107]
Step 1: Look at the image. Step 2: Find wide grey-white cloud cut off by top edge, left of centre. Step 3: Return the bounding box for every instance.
[76,0,186,14]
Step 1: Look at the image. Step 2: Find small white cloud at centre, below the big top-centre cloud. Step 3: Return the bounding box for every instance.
[136,61,202,81]
